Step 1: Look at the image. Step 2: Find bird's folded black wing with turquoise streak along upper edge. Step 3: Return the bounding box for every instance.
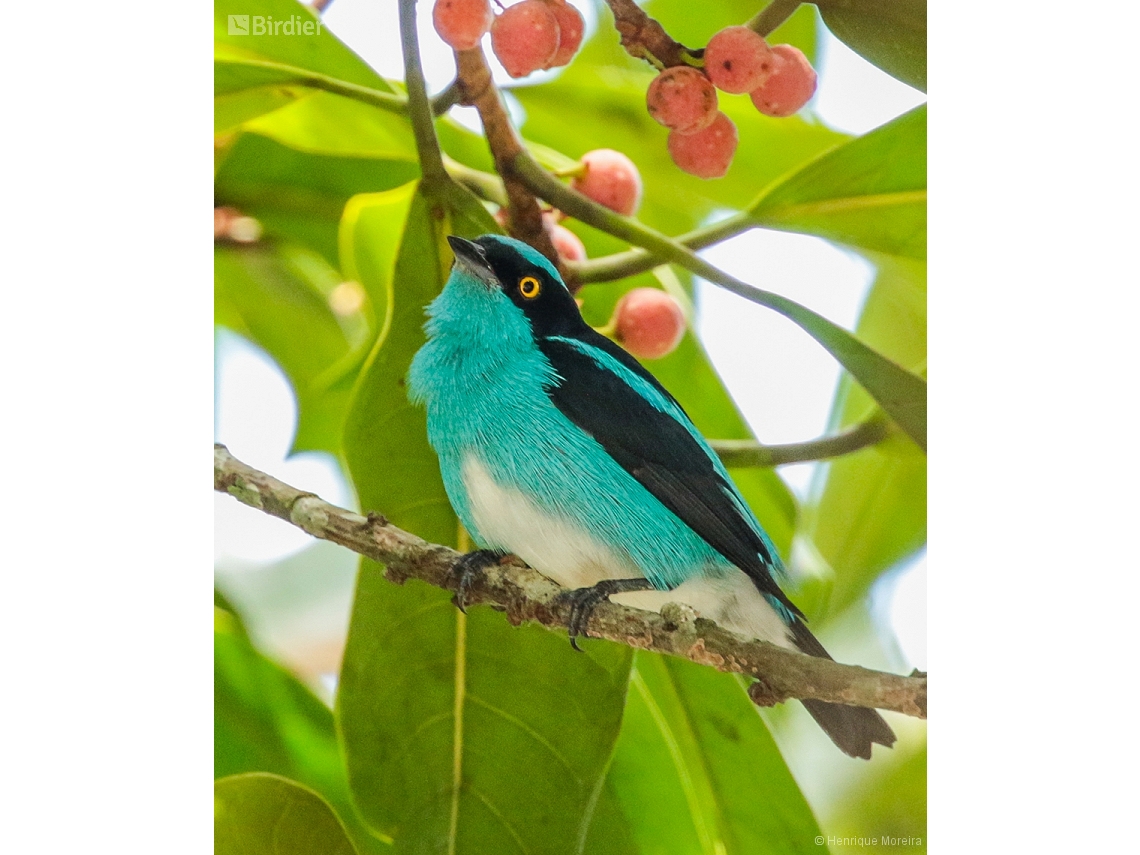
[538,329,803,617]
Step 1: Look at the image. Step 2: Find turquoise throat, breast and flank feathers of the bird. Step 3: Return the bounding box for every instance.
[408,261,728,588]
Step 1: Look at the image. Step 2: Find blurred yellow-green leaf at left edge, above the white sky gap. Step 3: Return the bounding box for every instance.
[214,242,368,454]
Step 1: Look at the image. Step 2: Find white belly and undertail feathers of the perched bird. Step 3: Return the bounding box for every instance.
[463,456,793,648]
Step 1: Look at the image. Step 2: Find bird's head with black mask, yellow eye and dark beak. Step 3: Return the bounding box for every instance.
[447,235,583,336]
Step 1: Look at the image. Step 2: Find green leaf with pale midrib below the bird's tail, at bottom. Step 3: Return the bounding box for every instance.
[608,652,821,855]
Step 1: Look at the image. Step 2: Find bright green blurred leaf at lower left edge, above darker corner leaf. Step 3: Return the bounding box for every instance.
[214,615,386,853]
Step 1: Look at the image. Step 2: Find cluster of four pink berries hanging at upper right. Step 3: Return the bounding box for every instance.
[645,26,816,178]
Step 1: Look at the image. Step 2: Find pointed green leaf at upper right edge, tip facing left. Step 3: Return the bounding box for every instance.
[749,105,927,259]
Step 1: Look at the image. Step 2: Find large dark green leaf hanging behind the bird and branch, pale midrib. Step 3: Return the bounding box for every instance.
[337,185,630,853]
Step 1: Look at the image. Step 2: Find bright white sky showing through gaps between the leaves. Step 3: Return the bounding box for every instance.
[214,0,926,668]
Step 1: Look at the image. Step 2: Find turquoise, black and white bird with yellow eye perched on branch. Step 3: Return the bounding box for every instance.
[407,235,896,759]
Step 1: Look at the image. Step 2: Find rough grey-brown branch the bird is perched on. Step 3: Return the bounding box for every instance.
[214,445,927,718]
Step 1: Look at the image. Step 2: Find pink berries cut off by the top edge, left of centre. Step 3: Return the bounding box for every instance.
[432,0,586,78]
